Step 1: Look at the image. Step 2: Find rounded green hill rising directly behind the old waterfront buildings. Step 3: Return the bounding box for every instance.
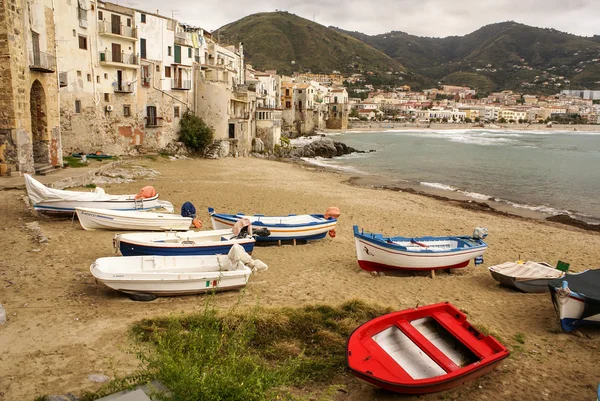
[212,12,406,75]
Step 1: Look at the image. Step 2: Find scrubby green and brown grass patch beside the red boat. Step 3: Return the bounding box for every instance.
[125,301,391,401]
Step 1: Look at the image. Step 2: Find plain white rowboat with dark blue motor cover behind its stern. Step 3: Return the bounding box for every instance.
[75,207,192,231]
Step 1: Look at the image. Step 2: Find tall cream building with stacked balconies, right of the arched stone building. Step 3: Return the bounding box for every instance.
[56,0,200,155]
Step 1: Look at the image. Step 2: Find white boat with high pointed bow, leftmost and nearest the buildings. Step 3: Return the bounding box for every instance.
[25,174,168,214]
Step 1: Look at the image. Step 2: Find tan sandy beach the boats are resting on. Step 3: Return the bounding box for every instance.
[0,157,600,401]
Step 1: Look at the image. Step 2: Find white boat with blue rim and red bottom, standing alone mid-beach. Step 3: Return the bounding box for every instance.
[354,226,487,271]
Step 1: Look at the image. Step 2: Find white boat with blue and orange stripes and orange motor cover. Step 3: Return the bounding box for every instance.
[208,208,337,241]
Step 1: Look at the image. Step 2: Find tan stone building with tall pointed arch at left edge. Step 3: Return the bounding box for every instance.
[0,0,62,175]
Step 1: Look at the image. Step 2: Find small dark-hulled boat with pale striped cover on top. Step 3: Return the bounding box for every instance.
[489,261,565,292]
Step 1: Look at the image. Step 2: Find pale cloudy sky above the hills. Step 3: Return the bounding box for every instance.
[126,0,600,37]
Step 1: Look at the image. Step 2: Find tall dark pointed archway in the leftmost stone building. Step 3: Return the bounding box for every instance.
[29,79,50,164]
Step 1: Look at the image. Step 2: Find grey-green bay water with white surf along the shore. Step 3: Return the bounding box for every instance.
[310,129,600,223]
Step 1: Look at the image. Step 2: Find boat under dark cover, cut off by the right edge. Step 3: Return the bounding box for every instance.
[548,269,600,332]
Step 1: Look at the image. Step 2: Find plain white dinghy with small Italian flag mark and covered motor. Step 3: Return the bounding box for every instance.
[90,244,267,300]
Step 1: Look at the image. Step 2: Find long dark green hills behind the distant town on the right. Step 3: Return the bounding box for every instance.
[334,22,600,92]
